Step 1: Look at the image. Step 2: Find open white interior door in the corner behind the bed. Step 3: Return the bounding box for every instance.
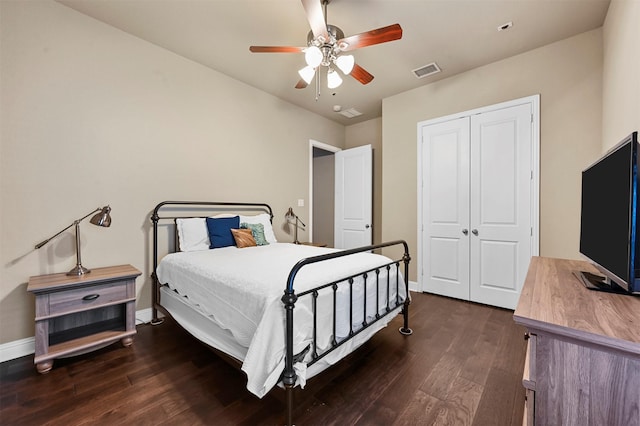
[334,145,373,249]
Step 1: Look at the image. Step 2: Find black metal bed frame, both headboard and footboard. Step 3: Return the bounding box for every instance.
[151,201,413,425]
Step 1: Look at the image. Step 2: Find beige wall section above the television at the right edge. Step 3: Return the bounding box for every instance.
[602,0,640,151]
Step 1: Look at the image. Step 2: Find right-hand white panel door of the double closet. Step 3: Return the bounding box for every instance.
[470,104,533,309]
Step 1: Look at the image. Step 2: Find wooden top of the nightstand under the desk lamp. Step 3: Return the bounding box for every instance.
[27,265,141,293]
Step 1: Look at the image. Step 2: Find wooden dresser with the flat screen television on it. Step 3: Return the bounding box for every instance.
[513,257,640,426]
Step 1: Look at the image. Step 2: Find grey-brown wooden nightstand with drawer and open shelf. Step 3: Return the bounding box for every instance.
[27,265,141,373]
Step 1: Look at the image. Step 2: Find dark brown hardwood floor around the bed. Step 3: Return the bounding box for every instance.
[0,294,525,426]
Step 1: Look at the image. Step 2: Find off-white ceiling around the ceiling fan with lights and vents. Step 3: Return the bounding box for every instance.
[58,0,609,125]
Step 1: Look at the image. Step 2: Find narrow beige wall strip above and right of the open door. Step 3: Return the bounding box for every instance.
[345,117,382,244]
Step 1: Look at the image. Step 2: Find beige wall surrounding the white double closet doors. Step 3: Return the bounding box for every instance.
[382,29,602,280]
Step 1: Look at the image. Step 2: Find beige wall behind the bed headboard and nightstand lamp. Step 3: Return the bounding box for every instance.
[0,0,345,344]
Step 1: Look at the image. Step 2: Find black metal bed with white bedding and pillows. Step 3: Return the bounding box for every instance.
[151,201,412,424]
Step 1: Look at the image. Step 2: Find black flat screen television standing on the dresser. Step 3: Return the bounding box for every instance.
[579,132,640,294]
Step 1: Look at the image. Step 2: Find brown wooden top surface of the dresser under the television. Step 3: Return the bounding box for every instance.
[513,257,640,355]
